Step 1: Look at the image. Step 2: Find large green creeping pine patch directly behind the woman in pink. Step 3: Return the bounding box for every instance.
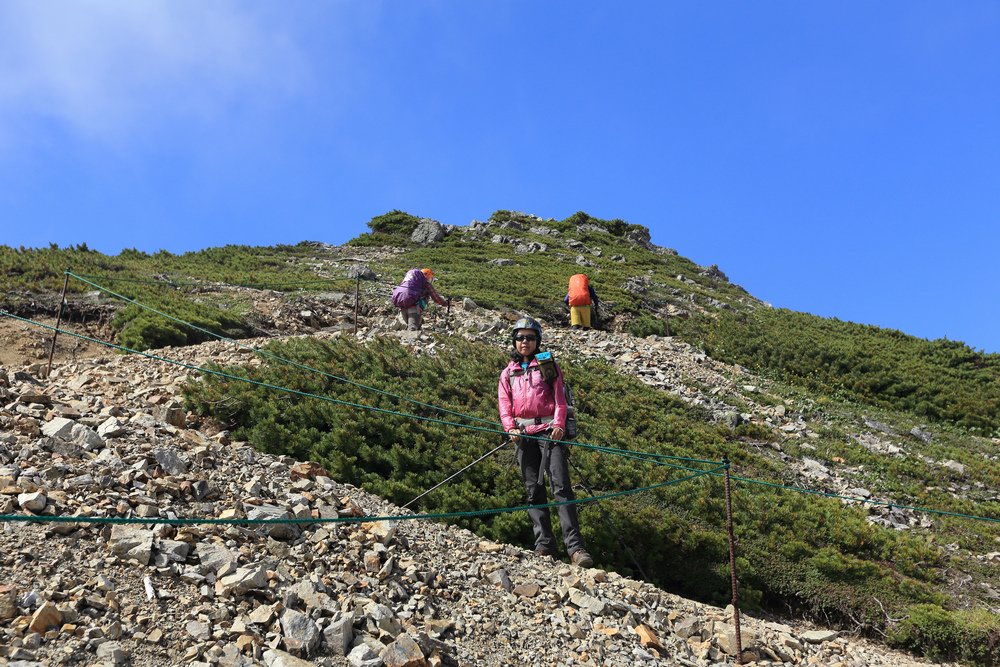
[185,338,968,656]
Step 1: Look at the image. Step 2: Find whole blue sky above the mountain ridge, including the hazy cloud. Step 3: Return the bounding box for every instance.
[0,0,1000,352]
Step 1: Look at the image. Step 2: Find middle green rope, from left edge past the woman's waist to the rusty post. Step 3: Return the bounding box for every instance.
[0,310,718,465]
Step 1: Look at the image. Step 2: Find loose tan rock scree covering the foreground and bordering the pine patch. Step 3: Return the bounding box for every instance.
[0,304,952,667]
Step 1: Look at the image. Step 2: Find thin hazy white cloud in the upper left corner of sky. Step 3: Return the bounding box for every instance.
[0,0,306,142]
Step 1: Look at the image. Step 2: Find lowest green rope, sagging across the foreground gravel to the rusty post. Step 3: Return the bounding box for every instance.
[0,466,722,526]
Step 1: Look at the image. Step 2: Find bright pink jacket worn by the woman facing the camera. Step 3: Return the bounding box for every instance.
[497,359,566,435]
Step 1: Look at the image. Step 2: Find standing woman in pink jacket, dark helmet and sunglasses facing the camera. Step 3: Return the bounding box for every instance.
[497,317,594,567]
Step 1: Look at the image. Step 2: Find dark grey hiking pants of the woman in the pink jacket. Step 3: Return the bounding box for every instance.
[517,437,583,553]
